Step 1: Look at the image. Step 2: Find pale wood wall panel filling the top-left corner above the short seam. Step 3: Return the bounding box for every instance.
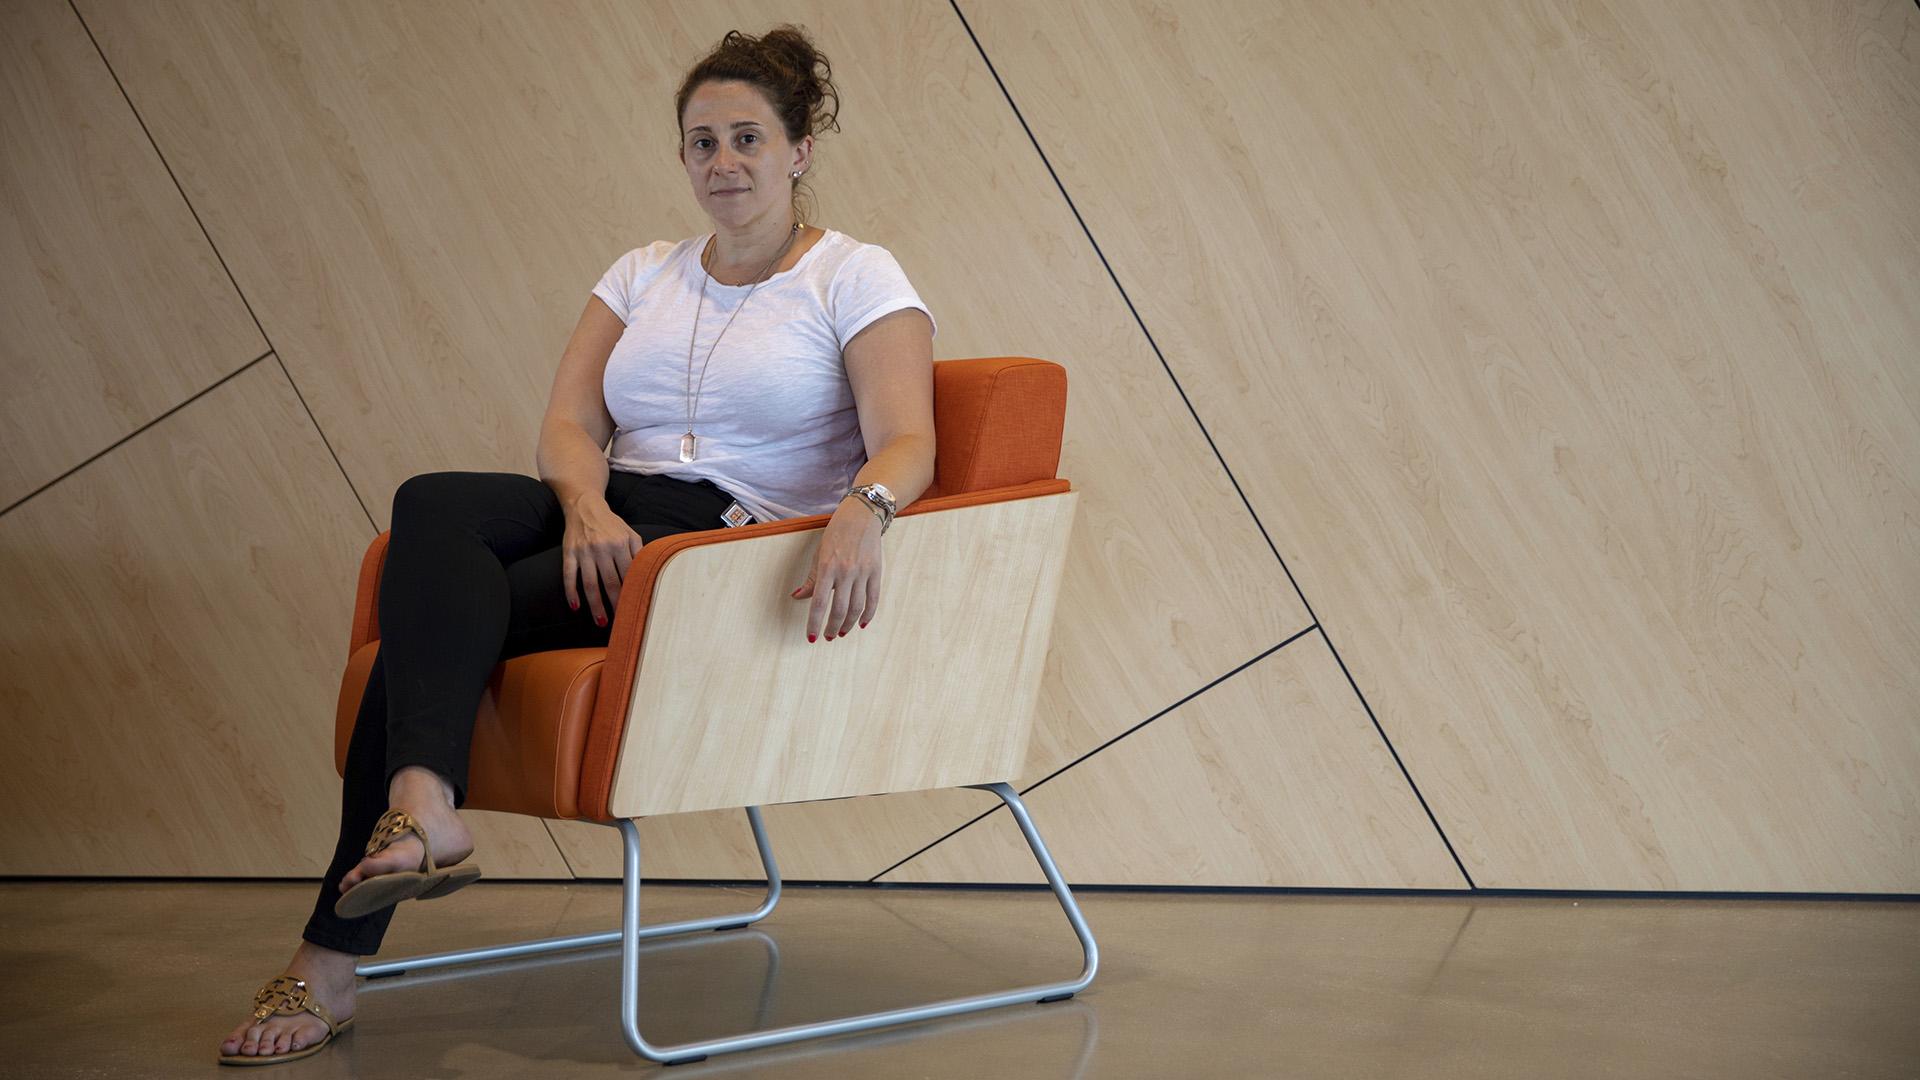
[0,0,267,507]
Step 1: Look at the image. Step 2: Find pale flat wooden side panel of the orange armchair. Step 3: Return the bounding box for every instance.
[607,492,1079,817]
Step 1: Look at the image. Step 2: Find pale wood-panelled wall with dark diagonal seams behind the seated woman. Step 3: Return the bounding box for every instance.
[0,0,1920,892]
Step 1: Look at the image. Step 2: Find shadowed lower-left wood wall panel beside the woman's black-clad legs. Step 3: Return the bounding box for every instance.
[0,357,566,876]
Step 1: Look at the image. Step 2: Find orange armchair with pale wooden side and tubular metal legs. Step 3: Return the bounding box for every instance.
[334,357,1098,1065]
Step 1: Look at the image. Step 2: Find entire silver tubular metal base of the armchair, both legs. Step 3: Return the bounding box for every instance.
[355,784,1100,1065]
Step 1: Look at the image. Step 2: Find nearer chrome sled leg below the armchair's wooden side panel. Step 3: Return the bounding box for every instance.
[620,784,1100,1065]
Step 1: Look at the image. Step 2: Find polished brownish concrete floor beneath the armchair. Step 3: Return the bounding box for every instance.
[0,882,1920,1080]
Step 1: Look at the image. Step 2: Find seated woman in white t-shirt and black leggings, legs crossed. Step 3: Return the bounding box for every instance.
[221,27,933,1065]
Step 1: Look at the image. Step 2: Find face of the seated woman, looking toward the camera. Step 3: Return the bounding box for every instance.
[680,81,814,229]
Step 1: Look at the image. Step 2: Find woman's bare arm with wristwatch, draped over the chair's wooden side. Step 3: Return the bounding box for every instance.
[793,307,933,642]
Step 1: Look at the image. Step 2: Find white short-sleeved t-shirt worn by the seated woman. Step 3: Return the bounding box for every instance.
[593,229,933,521]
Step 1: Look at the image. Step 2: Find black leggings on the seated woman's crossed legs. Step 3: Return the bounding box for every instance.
[301,471,733,955]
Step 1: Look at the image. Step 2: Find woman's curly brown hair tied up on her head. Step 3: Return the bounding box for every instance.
[674,23,839,216]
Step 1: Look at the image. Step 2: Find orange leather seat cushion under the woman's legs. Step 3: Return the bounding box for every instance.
[334,640,607,819]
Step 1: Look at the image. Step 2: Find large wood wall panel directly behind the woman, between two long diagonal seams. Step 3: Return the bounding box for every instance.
[81,0,1309,876]
